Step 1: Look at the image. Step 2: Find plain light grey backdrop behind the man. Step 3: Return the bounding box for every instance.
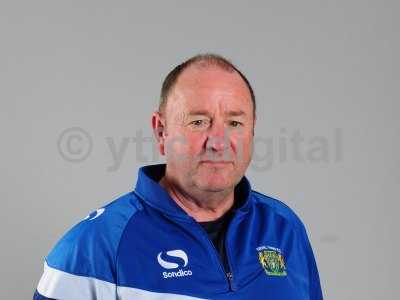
[0,1,400,300]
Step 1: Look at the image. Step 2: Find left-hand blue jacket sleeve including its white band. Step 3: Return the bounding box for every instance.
[33,194,136,300]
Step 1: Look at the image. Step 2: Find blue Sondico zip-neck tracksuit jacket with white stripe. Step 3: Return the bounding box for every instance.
[33,165,322,300]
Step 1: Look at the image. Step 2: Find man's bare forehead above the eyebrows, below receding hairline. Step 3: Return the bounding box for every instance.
[168,66,252,110]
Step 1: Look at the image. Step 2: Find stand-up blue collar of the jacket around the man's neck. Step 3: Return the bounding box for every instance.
[135,164,251,219]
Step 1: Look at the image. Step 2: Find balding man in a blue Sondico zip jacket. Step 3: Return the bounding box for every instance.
[34,55,322,300]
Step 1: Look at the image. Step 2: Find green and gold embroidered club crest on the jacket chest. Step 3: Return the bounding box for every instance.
[257,246,287,276]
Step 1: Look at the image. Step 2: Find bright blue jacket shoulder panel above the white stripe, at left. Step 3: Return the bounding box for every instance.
[46,193,141,282]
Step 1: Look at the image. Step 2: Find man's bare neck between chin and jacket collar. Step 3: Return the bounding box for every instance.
[159,176,234,222]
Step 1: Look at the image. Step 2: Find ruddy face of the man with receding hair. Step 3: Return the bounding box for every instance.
[159,66,254,192]
